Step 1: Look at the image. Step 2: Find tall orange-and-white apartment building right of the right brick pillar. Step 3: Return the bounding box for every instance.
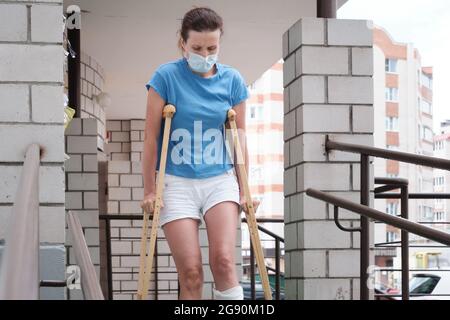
[373,27,434,285]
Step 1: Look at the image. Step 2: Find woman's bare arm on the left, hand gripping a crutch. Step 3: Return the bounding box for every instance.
[141,87,165,212]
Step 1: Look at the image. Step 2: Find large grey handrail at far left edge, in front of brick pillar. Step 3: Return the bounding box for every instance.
[0,144,40,300]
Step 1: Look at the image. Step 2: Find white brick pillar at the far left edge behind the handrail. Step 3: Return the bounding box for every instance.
[0,0,65,299]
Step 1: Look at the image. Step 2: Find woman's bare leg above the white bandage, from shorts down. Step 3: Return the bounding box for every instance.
[204,201,240,292]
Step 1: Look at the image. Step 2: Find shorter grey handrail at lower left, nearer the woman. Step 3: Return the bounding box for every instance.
[67,211,104,300]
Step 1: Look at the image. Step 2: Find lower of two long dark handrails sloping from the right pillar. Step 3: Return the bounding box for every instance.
[306,188,450,246]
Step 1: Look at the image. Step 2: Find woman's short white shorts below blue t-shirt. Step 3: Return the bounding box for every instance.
[159,168,240,227]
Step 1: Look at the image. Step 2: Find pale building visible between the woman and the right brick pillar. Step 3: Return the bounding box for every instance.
[242,59,284,271]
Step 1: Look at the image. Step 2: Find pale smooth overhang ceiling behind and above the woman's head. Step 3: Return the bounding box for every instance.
[64,0,348,119]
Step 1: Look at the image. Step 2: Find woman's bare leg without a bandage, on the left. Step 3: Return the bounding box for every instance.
[162,218,203,300]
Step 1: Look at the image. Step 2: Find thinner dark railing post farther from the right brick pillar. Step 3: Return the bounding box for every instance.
[400,185,409,300]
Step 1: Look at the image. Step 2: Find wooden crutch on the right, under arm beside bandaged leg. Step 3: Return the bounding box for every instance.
[228,109,272,300]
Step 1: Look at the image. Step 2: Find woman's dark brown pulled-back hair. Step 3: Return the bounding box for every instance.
[178,7,224,53]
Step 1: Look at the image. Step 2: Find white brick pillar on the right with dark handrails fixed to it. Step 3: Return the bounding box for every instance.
[283,18,373,299]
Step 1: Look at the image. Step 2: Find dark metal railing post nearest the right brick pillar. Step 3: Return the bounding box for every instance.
[360,154,370,300]
